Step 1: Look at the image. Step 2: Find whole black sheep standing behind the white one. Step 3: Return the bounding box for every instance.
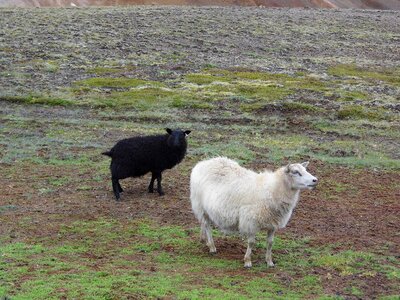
[102,128,190,201]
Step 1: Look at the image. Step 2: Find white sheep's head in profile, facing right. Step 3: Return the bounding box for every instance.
[285,162,318,190]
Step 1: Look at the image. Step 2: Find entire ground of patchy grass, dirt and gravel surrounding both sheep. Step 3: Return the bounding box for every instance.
[0,7,400,299]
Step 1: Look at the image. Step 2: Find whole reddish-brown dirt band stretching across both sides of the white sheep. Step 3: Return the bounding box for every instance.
[0,163,400,250]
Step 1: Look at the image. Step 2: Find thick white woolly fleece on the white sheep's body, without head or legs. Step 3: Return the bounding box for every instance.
[190,157,298,234]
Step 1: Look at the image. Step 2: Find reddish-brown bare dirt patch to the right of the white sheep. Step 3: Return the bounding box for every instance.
[286,165,400,255]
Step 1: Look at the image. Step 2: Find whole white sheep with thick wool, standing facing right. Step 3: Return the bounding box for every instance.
[190,157,318,268]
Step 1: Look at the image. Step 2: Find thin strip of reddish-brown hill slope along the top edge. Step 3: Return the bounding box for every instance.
[0,0,400,10]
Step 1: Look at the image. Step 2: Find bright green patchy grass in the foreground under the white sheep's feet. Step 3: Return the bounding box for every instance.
[0,219,399,299]
